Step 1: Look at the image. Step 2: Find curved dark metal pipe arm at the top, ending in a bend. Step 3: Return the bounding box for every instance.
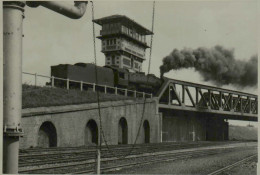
[26,1,88,19]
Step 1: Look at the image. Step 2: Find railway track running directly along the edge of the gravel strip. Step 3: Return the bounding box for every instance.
[19,150,236,174]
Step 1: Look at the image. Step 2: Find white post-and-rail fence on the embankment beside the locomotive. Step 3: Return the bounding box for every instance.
[22,72,153,98]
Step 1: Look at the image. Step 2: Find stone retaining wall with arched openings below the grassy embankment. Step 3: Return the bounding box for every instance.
[20,99,161,149]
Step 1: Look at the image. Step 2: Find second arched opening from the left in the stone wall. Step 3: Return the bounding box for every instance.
[85,120,98,145]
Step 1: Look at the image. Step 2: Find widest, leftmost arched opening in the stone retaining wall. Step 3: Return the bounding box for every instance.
[38,122,57,148]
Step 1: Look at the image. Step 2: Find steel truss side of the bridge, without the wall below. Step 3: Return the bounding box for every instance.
[159,79,258,114]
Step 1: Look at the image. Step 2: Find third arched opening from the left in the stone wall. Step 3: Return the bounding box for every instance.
[118,117,128,144]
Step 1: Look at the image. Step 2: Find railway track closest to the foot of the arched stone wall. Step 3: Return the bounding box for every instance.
[19,142,242,167]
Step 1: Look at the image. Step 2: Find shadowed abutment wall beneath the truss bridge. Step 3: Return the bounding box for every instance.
[162,110,228,142]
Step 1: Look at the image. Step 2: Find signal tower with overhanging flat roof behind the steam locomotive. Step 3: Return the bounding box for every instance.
[94,15,153,72]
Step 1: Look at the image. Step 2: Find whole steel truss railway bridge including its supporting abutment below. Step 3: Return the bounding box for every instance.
[156,78,258,141]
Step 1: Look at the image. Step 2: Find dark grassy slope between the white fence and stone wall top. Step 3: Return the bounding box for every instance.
[22,84,135,109]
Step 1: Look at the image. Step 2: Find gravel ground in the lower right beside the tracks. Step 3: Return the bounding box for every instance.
[111,148,257,175]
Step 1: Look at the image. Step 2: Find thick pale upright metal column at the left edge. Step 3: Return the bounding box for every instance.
[3,1,25,174]
